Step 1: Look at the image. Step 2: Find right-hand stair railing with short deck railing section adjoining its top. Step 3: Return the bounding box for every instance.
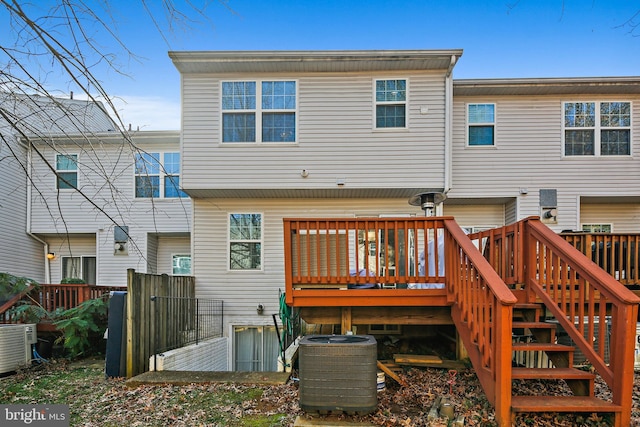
[470,218,640,425]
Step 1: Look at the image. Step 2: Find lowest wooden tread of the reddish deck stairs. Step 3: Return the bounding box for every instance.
[511,396,622,412]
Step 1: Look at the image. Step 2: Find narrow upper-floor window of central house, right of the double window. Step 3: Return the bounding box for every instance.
[375,79,407,129]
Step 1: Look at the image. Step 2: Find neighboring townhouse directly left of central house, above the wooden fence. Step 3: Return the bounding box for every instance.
[30,131,191,286]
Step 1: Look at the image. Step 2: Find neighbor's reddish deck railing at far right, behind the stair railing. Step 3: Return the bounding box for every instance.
[560,232,640,286]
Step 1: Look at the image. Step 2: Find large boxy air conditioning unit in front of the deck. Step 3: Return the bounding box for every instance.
[298,335,378,414]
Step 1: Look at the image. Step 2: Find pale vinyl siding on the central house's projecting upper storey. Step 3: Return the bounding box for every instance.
[182,73,445,190]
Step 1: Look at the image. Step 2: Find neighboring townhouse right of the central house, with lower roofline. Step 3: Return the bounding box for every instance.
[444,77,640,233]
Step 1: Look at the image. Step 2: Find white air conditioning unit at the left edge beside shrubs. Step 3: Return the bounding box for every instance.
[0,324,38,374]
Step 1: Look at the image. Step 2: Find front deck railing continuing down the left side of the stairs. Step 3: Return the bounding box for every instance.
[284,217,517,420]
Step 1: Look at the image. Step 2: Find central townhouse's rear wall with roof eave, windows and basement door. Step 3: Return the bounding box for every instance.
[170,50,462,370]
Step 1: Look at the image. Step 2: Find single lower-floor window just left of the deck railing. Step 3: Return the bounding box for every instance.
[229,213,262,270]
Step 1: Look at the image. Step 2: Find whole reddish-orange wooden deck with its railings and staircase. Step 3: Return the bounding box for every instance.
[284,217,640,427]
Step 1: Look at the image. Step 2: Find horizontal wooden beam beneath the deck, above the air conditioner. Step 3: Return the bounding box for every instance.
[300,307,453,325]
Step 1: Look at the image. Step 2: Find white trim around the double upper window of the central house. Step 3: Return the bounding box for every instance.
[218,78,300,147]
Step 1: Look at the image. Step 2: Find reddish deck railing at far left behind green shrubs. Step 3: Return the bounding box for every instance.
[0,284,127,323]
